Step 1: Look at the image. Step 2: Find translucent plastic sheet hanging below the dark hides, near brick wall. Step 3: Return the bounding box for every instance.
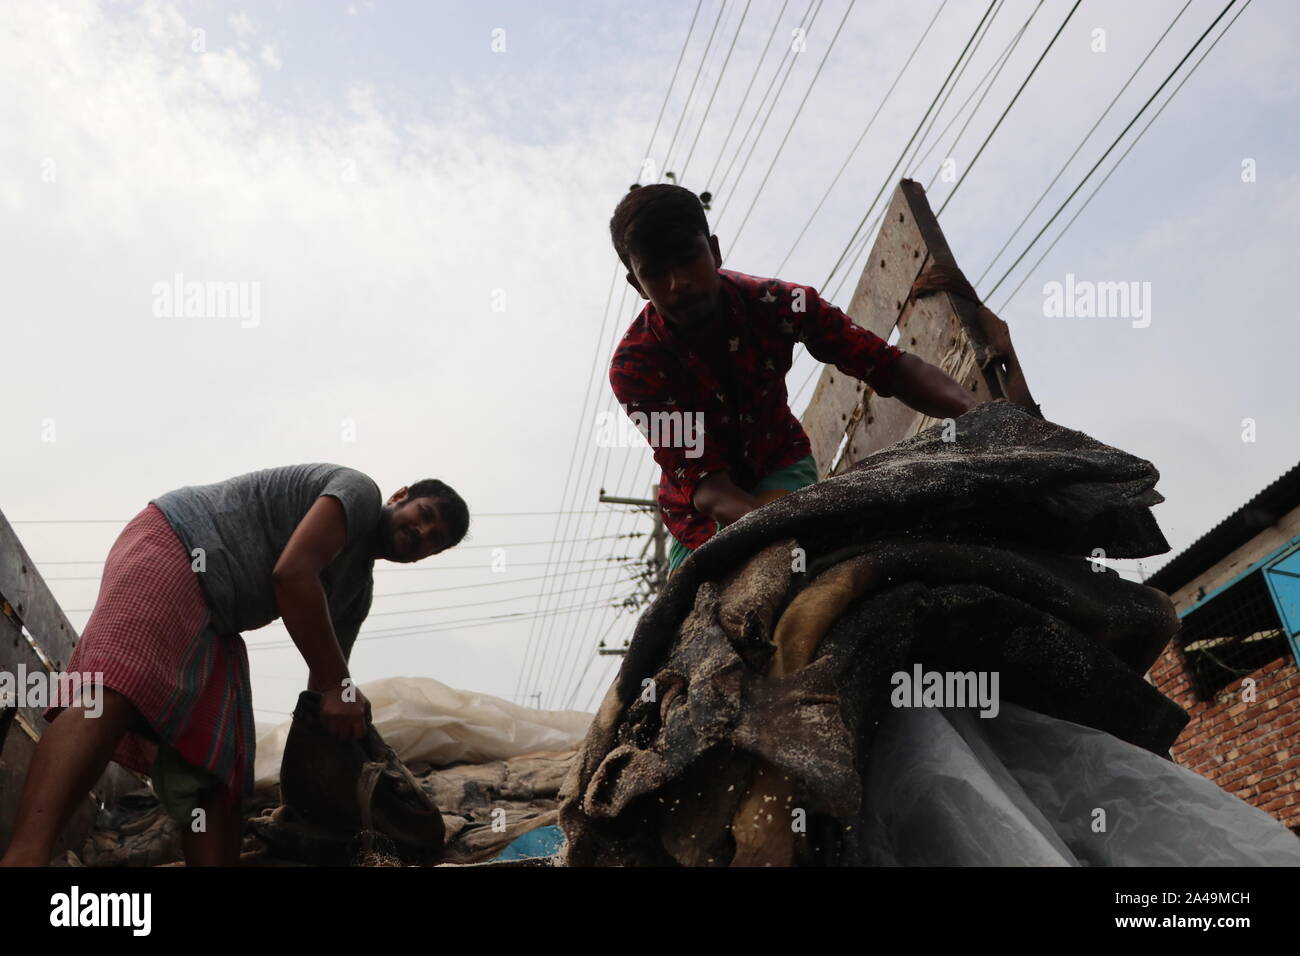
[866,702,1300,866]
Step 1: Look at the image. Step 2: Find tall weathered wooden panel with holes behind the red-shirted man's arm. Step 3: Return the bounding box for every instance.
[803,179,1037,477]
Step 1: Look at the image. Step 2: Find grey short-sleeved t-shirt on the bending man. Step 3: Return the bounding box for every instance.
[151,464,384,658]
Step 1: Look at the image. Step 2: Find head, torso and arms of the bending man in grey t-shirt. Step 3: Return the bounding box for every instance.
[151,464,469,737]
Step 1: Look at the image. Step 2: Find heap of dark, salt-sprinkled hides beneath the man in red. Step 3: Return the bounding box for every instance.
[560,402,1187,865]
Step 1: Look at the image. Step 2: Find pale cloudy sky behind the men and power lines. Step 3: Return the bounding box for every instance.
[0,0,1300,722]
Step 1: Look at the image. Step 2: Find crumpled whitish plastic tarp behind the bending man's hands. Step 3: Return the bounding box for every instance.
[254,678,592,787]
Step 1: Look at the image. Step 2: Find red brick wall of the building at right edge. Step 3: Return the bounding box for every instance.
[1151,643,1300,832]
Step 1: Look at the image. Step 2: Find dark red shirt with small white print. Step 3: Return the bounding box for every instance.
[610,269,902,550]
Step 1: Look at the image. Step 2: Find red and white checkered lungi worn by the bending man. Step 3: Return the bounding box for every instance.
[44,505,256,799]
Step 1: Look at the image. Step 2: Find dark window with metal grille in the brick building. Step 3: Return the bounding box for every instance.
[1178,571,1290,700]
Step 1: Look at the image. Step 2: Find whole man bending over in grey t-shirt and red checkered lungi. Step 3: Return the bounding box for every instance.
[0,464,469,865]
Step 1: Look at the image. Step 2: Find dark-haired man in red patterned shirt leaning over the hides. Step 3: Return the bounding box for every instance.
[610,183,975,568]
